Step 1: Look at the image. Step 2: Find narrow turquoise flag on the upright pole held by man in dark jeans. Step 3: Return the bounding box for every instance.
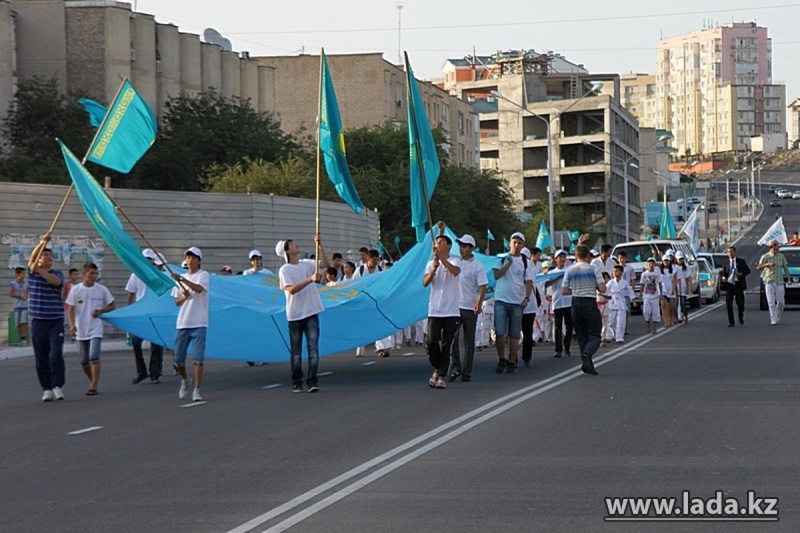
[319,50,364,213]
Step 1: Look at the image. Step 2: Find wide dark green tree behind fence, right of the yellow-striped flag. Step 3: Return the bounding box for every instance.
[125,89,301,191]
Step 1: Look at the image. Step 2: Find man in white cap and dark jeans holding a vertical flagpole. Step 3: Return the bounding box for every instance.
[275,234,330,393]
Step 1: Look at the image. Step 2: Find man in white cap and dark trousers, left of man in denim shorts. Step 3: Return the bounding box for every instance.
[448,235,489,382]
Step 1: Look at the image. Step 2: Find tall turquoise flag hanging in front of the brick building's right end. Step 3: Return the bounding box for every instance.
[404,54,441,242]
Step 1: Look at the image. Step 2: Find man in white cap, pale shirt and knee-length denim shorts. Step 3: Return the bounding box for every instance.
[492,232,535,374]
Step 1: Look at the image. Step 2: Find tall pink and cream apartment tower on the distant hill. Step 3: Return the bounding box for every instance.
[656,22,786,155]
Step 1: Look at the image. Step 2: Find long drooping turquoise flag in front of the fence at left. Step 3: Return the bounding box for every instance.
[58,141,175,295]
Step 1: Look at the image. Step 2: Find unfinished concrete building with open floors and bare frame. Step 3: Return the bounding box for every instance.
[450,53,642,242]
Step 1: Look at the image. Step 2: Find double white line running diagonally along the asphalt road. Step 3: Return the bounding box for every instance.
[229,316,718,533]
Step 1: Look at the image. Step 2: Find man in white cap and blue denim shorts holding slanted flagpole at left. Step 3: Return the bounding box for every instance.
[172,246,211,402]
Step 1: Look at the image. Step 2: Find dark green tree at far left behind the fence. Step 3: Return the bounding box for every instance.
[0,77,94,184]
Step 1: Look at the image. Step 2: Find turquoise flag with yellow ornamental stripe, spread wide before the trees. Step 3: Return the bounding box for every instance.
[86,80,158,174]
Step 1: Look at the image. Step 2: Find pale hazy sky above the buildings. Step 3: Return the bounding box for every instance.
[131,0,800,97]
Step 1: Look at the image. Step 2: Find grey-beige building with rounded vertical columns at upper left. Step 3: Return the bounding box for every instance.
[0,0,274,120]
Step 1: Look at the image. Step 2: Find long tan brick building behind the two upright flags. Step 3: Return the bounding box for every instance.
[255,53,479,168]
